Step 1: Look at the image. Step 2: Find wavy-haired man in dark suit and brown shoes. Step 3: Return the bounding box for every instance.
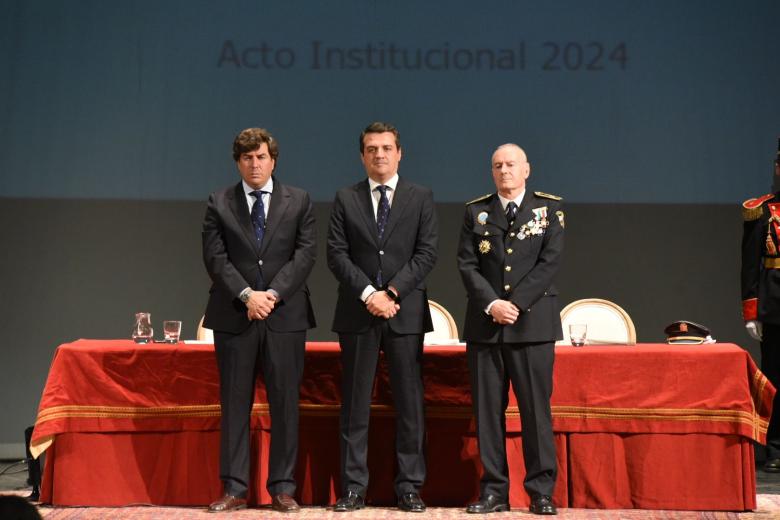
[203,128,316,512]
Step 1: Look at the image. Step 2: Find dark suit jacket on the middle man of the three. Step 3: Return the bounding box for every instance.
[327,178,438,334]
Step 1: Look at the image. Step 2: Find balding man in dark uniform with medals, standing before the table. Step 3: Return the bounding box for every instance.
[458,144,563,515]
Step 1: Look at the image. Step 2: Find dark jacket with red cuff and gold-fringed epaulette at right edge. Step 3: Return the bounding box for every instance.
[742,193,780,325]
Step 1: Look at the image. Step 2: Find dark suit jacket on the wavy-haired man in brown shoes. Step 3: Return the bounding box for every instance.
[203,177,317,334]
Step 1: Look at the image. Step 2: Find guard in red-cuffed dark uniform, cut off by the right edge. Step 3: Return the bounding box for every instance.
[742,138,780,473]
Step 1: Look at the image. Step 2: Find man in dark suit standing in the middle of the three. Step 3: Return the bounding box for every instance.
[327,123,437,512]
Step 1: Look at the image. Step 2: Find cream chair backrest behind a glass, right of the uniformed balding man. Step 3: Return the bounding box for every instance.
[558,298,636,345]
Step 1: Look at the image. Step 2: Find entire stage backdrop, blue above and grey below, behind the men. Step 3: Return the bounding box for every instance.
[0,0,780,457]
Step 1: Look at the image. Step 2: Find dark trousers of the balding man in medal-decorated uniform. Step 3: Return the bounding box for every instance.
[466,343,558,500]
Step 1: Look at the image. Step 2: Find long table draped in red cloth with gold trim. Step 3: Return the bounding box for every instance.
[32,340,775,511]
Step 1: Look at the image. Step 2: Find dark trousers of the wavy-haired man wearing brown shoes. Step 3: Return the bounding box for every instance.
[214,321,306,497]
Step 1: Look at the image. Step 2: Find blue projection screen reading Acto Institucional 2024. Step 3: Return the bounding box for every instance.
[0,0,780,204]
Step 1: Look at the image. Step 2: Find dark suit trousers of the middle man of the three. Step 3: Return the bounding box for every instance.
[339,323,426,496]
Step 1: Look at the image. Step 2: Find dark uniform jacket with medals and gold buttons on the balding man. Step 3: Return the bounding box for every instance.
[458,190,563,343]
